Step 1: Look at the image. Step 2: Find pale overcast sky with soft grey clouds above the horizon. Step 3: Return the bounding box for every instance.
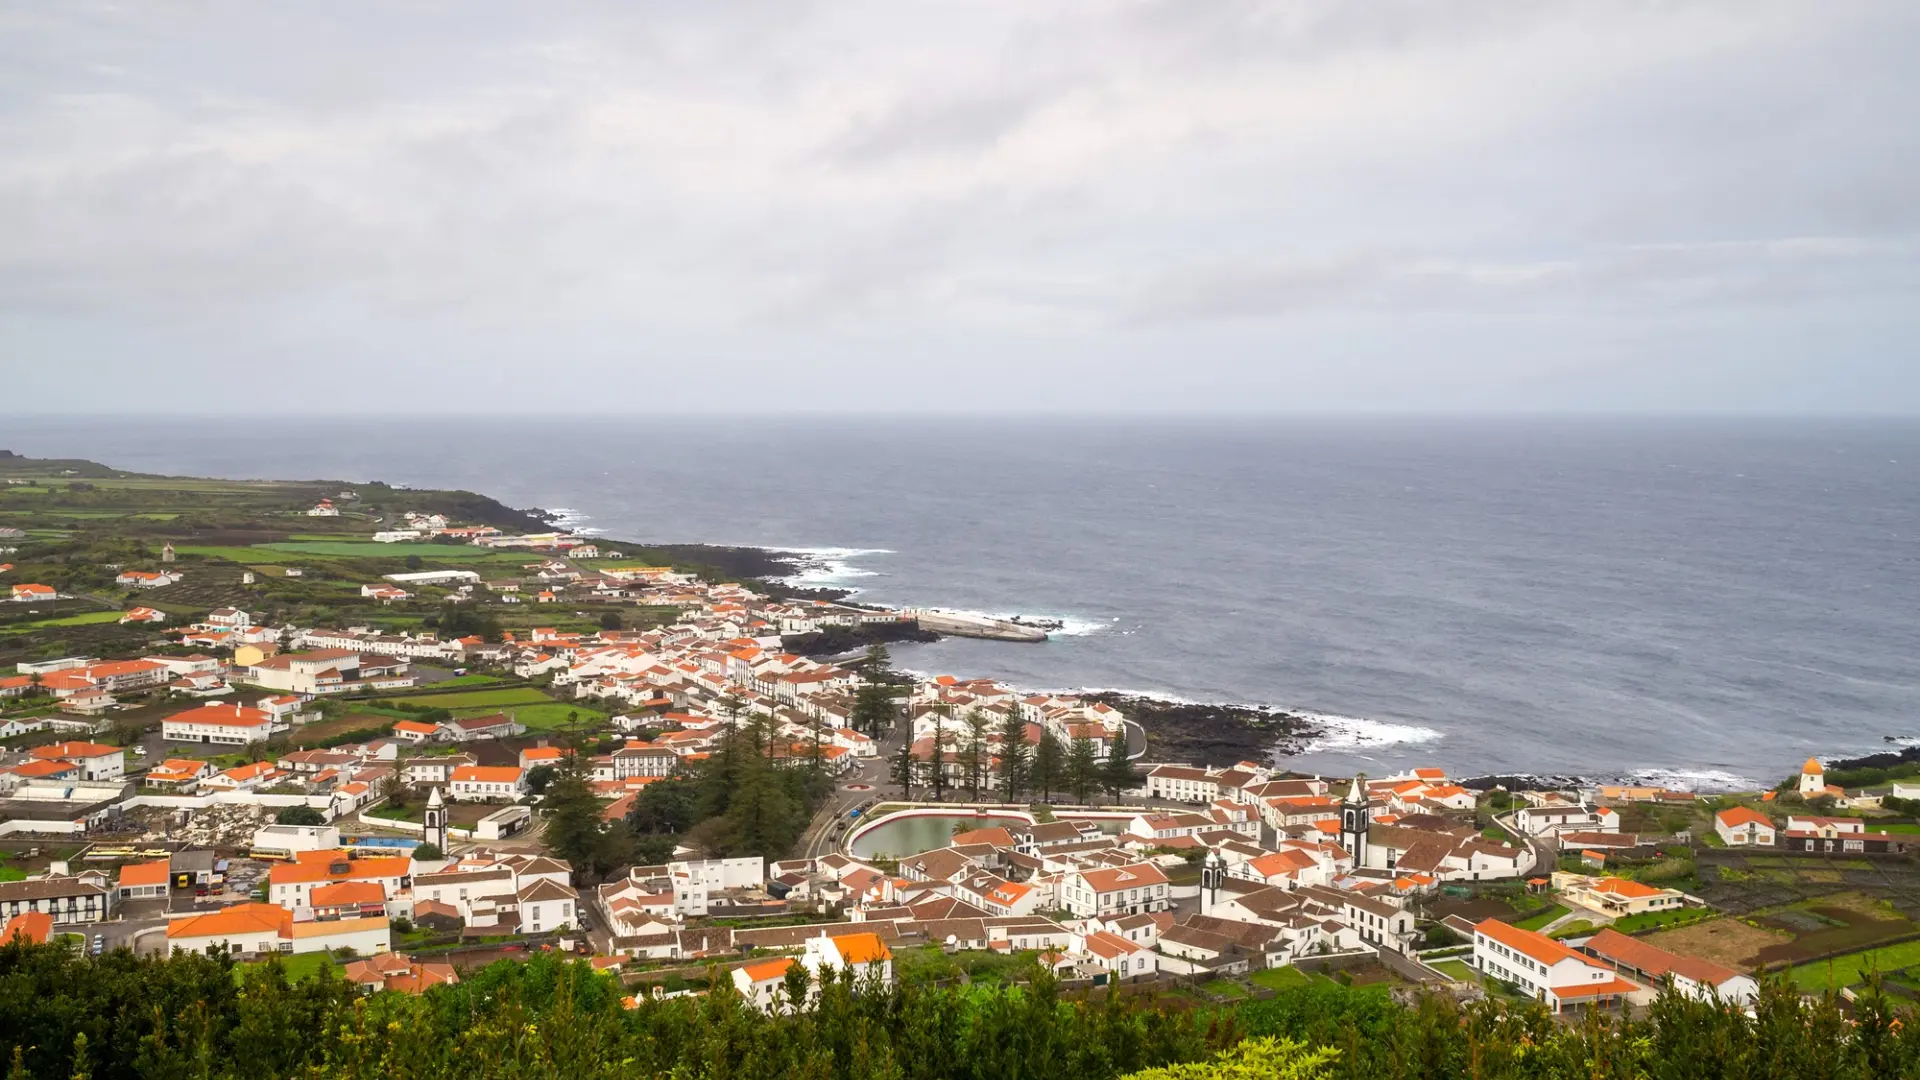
[0,0,1920,417]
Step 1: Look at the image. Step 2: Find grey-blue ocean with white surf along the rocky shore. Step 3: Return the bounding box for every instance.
[0,417,1920,790]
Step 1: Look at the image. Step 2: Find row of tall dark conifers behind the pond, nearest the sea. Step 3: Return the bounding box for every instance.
[891,709,1139,803]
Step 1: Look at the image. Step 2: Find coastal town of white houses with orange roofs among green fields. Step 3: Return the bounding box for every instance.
[0,455,1920,1015]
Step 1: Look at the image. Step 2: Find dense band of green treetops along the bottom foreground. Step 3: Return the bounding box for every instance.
[0,942,1920,1080]
